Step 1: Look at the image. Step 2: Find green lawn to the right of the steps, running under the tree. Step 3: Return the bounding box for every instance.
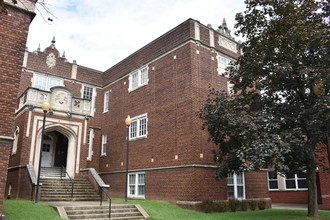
[113,199,330,220]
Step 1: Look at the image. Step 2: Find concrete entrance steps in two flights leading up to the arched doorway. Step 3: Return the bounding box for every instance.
[40,175,148,220]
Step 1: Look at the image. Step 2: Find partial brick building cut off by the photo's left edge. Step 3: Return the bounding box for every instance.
[0,0,35,215]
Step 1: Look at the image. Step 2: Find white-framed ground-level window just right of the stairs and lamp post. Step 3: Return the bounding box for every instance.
[128,173,145,197]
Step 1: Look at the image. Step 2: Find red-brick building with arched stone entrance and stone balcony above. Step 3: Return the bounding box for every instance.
[6,19,328,208]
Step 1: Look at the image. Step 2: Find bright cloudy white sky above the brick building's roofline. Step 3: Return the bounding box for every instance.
[27,0,245,71]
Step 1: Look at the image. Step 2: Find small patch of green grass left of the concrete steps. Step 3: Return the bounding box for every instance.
[4,200,63,220]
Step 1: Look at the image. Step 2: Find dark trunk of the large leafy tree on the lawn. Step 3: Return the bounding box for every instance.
[307,166,319,218]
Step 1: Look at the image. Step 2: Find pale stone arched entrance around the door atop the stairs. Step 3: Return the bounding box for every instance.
[34,125,76,178]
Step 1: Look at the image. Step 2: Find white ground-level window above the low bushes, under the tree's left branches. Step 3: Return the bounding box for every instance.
[227,173,245,199]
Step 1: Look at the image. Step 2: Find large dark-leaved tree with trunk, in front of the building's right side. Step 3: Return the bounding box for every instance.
[198,0,330,217]
